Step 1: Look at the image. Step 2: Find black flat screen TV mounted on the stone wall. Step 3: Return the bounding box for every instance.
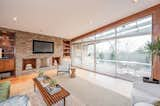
[33,40,54,53]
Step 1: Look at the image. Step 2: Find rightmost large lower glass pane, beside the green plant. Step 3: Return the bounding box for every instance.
[117,35,151,80]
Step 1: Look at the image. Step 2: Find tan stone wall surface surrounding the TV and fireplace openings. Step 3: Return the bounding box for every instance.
[0,28,63,75]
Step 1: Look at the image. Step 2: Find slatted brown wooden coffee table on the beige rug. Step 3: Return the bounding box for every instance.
[33,78,70,106]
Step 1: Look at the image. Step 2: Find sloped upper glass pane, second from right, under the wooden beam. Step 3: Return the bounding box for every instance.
[96,29,115,40]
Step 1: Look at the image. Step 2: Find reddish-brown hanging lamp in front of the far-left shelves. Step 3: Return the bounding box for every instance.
[0,32,11,47]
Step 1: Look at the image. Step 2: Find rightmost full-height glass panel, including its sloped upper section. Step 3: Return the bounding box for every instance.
[116,17,152,80]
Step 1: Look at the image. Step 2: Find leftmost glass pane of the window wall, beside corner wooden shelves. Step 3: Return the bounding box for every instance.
[72,44,82,66]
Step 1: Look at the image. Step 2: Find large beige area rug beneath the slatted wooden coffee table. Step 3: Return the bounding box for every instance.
[11,75,131,106]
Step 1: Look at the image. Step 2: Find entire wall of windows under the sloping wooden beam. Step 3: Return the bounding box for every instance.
[72,16,152,80]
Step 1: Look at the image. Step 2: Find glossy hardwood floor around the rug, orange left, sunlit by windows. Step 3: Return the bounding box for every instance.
[0,69,133,98]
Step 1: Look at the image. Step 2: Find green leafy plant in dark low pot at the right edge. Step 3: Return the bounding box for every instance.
[143,38,160,83]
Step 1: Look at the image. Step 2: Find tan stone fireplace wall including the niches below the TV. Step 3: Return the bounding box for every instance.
[0,28,63,76]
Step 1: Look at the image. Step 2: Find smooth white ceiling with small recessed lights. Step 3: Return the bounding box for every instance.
[0,0,160,39]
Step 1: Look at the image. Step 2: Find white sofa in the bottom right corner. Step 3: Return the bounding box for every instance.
[132,80,160,106]
